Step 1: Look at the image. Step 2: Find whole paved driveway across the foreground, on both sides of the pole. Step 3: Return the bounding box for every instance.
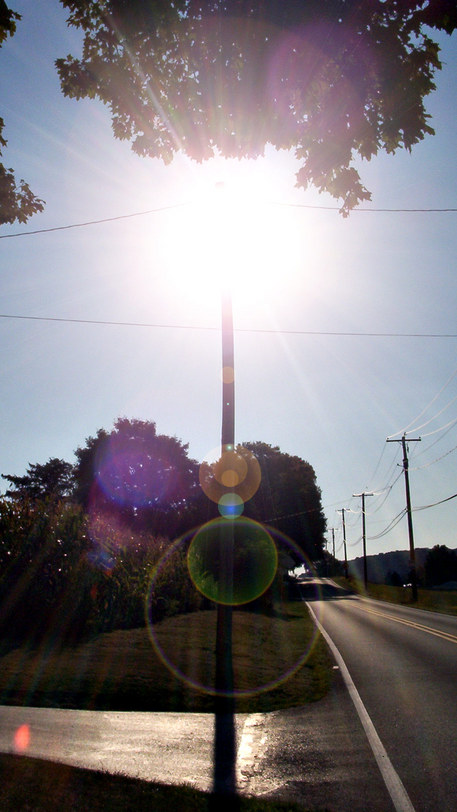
[0,674,392,812]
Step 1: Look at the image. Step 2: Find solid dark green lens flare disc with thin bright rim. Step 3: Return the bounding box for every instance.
[187,518,278,606]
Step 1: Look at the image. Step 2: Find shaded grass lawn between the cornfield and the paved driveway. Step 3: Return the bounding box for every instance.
[0,603,331,712]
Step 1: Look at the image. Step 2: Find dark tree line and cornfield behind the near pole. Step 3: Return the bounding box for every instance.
[0,418,325,645]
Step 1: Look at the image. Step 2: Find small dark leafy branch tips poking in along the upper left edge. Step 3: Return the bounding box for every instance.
[0,0,44,225]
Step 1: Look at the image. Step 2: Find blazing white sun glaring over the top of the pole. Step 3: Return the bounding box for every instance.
[151,162,302,318]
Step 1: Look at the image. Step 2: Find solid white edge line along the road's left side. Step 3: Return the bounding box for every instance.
[306,602,415,812]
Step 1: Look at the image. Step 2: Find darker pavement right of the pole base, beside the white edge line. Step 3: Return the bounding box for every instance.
[241,669,393,812]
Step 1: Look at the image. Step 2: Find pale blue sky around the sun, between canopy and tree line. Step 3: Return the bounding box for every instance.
[0,0,457,558]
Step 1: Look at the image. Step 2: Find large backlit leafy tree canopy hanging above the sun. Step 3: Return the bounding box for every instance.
[56,0,457,215]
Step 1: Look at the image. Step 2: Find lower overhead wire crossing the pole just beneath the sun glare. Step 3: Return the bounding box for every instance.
[0,313,457,338]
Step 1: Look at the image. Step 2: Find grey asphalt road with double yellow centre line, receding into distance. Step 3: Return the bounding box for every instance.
[309,585,457,812]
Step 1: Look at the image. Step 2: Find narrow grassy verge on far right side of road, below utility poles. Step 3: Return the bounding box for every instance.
[333,577,457,615]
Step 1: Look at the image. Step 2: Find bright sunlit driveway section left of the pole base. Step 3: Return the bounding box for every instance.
[0,706,213,790]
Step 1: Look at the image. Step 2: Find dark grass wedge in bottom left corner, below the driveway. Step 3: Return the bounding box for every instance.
[0,754,324,812]
